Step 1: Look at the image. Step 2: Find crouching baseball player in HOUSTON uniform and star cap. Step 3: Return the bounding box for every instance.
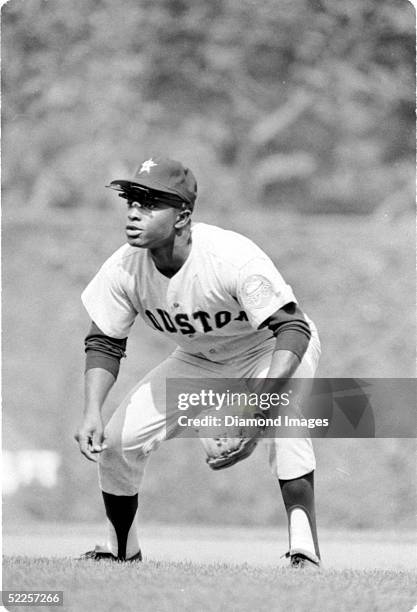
[75,157,320,567]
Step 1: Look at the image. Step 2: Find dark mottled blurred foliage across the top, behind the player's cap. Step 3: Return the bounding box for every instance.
[2,0,415,214]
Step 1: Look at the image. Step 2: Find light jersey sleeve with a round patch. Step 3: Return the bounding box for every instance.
[237,255,297,329]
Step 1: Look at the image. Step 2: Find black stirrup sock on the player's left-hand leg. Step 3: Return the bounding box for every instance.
[102,491,138,560]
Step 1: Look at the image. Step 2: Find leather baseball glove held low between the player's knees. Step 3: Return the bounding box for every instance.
[199,413,265,470]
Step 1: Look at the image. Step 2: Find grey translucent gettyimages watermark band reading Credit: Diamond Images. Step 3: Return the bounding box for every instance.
[166,378,417,438]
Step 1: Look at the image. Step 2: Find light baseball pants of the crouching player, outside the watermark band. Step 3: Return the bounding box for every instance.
[99,333,320,495]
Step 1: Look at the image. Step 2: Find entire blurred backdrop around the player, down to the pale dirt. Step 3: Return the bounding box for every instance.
[1,0,416,528]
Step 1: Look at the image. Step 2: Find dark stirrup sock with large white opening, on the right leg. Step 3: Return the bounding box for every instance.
[279,471,320,559]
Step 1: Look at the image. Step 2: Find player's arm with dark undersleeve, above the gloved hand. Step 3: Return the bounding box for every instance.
[260,302,311,391]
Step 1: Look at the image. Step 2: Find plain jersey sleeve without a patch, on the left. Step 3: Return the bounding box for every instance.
[81,266,137,338]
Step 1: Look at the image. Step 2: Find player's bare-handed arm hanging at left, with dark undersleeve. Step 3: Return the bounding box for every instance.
[75,322,127,461]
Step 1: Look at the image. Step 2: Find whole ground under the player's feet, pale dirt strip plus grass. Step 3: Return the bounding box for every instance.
[3,524,417,612]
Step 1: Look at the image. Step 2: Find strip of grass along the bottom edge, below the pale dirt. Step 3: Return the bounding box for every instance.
[4,557,416,612]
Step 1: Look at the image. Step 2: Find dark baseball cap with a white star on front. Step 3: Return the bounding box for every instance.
[111,157,197,207]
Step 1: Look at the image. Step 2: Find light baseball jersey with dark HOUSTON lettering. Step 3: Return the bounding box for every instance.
[82,223,296,362]
